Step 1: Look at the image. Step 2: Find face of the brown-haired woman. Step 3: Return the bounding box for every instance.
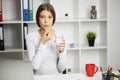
[39,10,53,30]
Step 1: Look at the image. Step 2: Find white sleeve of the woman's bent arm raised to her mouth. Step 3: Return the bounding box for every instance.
[26,35,46,70]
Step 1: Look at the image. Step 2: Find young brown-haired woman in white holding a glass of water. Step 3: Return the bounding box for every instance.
[26,3,66,74]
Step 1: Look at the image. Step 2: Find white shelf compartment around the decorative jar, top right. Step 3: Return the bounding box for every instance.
[79,0,107,19]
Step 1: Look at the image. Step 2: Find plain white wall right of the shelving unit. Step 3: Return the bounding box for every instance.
[108,0,120,68]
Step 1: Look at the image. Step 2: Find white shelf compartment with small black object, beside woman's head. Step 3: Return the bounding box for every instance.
[50,0,79,19]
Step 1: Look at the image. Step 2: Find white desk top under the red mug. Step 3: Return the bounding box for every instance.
[34,72,102,80]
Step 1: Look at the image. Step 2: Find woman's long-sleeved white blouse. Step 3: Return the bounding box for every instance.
[26,31,66,74]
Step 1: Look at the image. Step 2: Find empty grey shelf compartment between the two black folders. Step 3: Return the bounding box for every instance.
[3,24,22,50]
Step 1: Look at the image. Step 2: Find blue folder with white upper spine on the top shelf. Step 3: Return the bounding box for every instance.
[23,0,29,21]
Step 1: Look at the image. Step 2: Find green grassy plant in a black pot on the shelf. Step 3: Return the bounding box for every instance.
[86,31,96,47]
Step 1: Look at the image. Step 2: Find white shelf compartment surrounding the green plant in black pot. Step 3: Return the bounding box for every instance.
[80,21,107,47]
